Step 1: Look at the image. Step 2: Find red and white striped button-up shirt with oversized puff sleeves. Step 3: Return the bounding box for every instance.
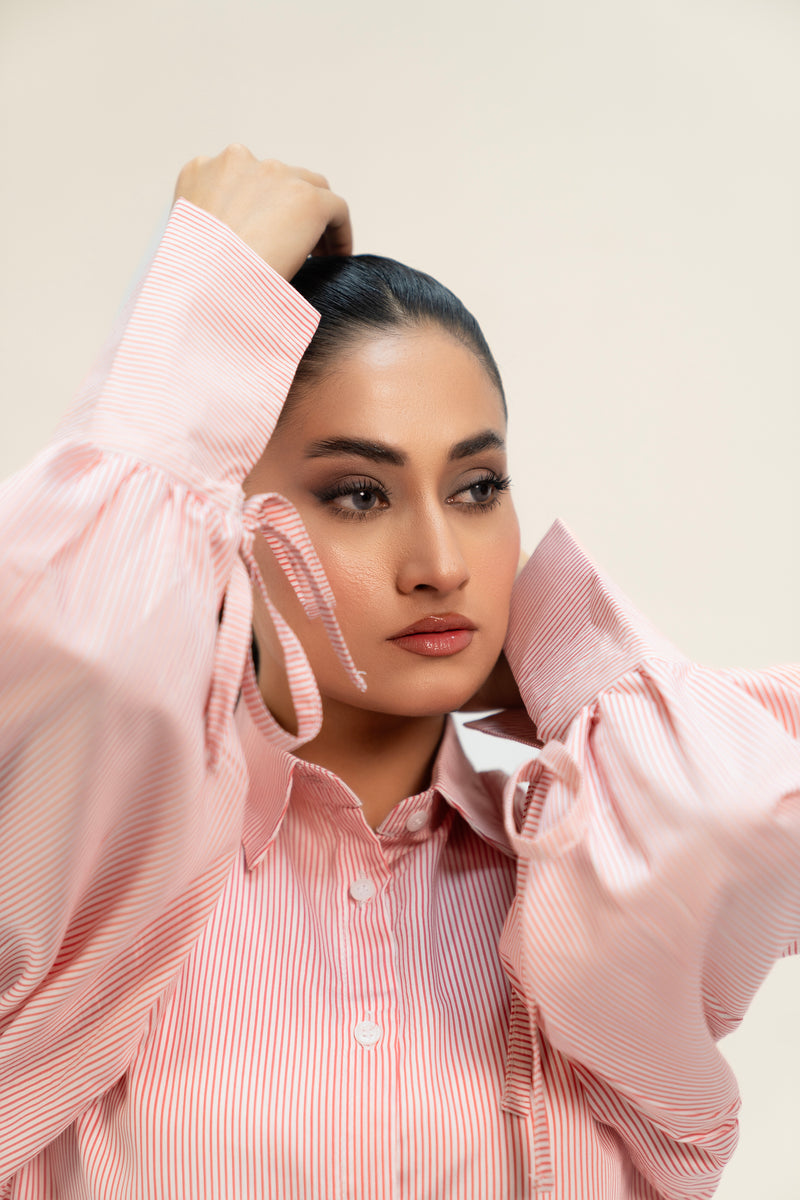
[0,202,800,1200]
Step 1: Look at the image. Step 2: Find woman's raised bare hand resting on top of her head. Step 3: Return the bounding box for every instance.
[175,145,353,280]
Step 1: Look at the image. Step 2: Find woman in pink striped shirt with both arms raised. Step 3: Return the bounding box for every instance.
[0,148,800,1200]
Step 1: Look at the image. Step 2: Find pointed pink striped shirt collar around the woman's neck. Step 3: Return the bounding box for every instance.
[236,697,513,870]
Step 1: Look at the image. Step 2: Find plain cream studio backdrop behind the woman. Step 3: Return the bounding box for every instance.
[0,0,800,1200]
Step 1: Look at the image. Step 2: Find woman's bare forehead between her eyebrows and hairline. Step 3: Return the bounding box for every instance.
[281,326,506,446]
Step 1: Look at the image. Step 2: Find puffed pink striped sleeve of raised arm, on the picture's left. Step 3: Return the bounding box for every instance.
[0,200,335,1181]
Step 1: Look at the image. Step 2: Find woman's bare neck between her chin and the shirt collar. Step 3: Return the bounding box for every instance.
[295,700,445,829]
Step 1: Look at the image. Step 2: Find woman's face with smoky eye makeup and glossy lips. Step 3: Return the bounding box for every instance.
[246,325,519,728]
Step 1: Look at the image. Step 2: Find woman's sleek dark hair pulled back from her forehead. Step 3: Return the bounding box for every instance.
[284,254,506,413]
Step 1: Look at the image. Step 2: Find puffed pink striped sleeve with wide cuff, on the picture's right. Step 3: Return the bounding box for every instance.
[500,523,800,1200]
